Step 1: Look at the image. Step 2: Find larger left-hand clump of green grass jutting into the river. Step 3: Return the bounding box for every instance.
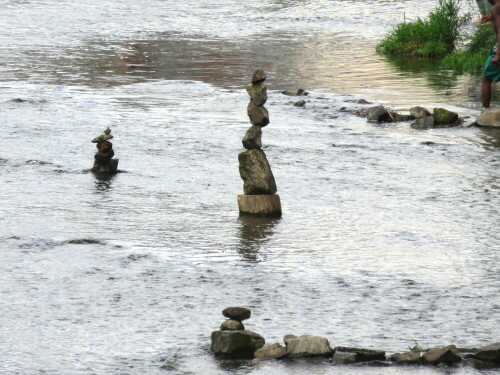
[376,0,470,57]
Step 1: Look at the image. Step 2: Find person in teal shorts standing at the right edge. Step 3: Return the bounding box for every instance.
[481,0,500,108]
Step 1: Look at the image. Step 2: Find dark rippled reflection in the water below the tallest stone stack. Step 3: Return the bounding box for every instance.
[238,216,280,262]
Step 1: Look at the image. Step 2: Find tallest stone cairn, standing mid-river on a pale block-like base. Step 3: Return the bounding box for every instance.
[238,69,281,217]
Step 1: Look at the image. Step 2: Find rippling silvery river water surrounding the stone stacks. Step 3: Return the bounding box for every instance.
[0,0,500,375]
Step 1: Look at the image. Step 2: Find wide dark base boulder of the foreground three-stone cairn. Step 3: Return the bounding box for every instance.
[211,331,265,359]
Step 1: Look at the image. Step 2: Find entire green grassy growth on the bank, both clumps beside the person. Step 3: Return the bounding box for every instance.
[376,0,496,73]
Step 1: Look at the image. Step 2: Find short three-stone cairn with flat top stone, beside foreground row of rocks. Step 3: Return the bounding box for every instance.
[211,307,265,359]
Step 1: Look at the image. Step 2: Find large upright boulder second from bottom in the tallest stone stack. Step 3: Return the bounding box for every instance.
[238,149,277,195]
